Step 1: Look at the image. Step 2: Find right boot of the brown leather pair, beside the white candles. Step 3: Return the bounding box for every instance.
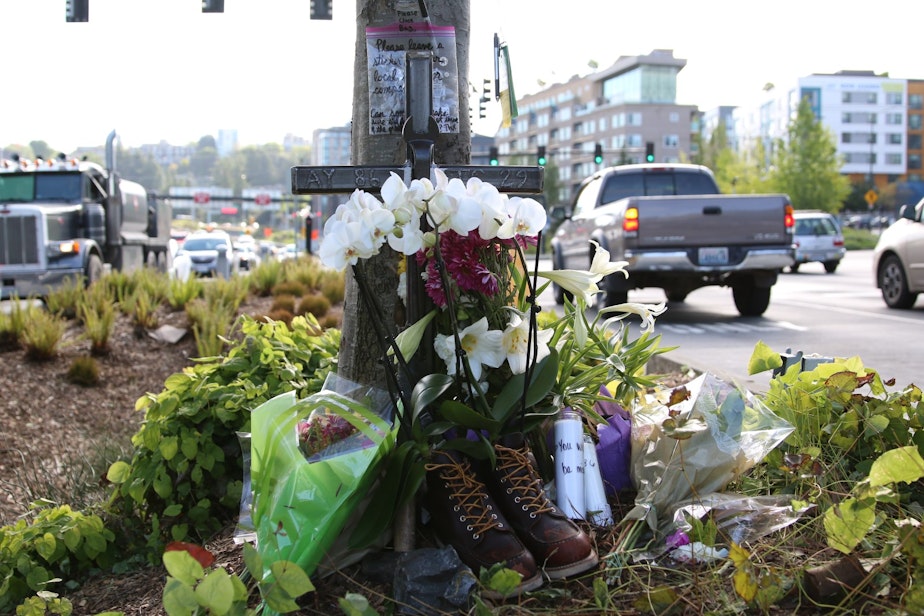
[480,433,599,580]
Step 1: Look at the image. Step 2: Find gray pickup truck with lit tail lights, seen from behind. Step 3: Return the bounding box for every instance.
[551,164,794,316]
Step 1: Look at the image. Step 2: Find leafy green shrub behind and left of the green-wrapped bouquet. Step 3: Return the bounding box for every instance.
[107,315,340,556]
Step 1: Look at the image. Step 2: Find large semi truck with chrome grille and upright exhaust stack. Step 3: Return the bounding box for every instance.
[0,131,173,299]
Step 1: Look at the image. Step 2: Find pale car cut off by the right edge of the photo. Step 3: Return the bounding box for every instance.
[873,199,924,309]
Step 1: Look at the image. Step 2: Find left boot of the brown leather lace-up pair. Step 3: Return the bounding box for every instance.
[426,451,543,596]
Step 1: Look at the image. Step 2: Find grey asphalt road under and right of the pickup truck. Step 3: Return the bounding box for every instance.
[542,250,924,392]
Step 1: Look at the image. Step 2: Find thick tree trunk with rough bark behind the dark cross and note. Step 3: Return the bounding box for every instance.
[348,0,471,551]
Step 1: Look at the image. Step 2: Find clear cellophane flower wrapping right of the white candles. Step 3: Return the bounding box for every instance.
[626,373,794,532]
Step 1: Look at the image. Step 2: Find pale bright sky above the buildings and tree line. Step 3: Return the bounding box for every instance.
[0,0,924,152]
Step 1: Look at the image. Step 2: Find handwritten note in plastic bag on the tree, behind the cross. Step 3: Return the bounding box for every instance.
[366,21,459,135]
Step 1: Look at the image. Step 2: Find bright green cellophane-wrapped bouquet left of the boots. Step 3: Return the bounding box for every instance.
[251,374,395,575]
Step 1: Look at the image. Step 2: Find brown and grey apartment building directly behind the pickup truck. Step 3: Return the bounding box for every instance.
[495,49,699,205]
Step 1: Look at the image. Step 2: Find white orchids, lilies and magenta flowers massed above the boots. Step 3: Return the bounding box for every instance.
[319,168,664,538]
